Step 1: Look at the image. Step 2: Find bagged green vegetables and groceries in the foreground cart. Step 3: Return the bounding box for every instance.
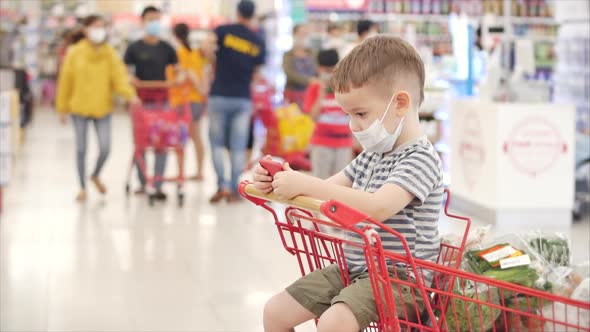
[447,232,590,331]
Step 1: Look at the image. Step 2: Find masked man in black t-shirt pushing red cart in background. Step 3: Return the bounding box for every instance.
[124,6,179,200]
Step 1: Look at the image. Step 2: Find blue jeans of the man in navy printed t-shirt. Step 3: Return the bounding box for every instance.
[209,96,252,193]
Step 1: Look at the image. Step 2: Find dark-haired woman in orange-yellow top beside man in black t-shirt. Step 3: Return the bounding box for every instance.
[170,23,210,181]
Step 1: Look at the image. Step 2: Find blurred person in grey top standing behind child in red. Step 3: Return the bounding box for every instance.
[283,24,317,108]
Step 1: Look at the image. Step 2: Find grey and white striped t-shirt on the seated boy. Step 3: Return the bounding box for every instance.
[344,137,444,280]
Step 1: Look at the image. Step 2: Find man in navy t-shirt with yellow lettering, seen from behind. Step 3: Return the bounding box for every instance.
[209,0,265,203]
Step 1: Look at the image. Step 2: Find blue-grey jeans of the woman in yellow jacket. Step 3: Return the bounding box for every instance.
[72,114,111,188]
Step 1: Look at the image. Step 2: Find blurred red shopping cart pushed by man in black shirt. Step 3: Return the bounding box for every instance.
[125,88,191,206]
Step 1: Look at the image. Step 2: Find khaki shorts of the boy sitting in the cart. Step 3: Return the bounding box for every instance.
[286,265,424,330]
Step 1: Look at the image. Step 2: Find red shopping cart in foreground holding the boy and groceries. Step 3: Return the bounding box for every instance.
[240,182,590,332]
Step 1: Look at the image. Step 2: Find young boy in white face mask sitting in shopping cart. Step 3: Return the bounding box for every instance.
[254,36,443,332]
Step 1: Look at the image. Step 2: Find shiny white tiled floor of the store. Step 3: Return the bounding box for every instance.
[0,112,589,332]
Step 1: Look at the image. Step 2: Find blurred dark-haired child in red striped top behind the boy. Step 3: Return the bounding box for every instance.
[303,49,353,179]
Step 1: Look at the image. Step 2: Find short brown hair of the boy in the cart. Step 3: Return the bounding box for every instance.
[331,36,425,105]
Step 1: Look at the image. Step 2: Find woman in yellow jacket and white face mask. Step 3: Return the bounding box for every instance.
[56,15,139,201]
